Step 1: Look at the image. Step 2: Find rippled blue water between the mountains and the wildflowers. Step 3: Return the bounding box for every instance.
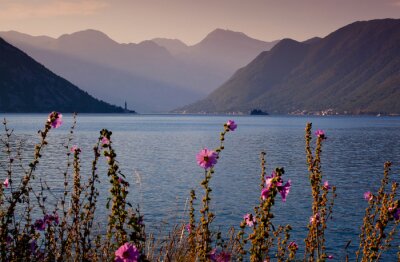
[0,114,400,261]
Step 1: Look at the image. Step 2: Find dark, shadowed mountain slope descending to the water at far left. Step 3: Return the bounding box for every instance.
[0,38,123,113]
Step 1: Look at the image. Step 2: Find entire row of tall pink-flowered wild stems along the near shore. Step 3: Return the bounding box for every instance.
[0,112,400,262]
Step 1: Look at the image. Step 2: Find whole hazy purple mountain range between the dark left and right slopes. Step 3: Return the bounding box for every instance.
[0,30,280,112]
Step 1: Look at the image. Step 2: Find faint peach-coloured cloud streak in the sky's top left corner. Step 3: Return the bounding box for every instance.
[0,0,107,20]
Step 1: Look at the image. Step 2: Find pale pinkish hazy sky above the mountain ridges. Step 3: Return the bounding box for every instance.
[0,0,400,44]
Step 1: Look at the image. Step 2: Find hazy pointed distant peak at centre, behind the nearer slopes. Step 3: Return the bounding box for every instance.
[153,29,278,86]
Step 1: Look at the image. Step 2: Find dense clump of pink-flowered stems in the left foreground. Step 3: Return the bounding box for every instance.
[0,112,145,261]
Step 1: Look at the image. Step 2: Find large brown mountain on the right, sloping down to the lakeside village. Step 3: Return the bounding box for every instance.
[179,19,400,114]
